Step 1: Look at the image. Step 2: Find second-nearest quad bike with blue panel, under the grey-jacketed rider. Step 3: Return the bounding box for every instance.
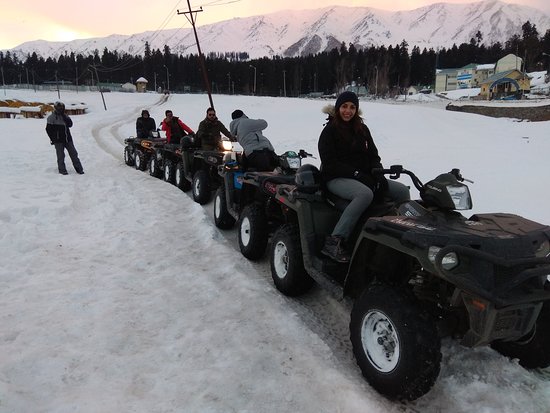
[214,149,312,260]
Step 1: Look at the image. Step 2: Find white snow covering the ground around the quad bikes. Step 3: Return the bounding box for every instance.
[0,90,550,413]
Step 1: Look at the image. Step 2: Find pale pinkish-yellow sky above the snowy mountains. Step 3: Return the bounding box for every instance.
[0,0,550,50]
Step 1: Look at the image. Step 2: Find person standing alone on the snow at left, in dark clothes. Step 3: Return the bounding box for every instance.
[46,102,84,175]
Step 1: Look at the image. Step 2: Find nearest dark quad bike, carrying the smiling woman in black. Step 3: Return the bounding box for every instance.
[270,165,550,400]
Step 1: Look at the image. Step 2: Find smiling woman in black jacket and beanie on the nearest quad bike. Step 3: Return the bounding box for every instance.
[318,91,410,262]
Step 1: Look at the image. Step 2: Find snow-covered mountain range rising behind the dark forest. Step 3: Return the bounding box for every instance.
[5,0,550,58]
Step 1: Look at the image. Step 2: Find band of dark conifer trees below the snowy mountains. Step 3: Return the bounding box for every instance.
[0,21,550,96]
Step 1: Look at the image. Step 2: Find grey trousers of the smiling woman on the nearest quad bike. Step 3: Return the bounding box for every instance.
[327,178,411,241]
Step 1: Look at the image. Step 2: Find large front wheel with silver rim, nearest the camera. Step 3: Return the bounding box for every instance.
[350,284,441,400]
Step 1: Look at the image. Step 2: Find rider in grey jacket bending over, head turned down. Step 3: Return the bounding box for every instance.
[229,109,278,171]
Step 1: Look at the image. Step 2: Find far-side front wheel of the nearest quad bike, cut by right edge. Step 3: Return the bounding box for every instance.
[491,302,550,369]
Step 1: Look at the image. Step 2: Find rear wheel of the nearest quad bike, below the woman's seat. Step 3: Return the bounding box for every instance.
[270,224,313,296]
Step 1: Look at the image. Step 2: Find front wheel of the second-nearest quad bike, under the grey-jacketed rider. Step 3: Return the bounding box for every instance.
[237,204,269,261]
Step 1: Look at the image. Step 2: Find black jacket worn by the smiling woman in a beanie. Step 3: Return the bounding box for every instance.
[318,121,382,182]
